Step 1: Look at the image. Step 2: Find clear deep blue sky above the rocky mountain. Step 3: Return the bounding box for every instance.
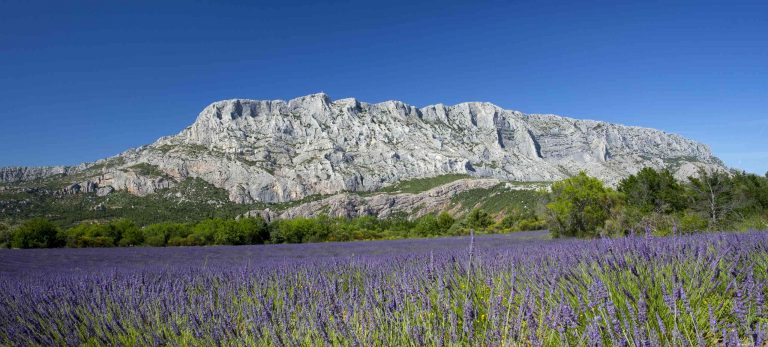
[0,0,768,174]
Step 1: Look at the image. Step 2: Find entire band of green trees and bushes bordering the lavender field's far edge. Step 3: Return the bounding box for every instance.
[0,168,768,248]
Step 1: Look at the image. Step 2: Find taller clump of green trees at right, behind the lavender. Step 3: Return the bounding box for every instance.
[543,168,768,237]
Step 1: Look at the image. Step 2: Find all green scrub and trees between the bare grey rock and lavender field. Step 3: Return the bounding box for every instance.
[0,168,768,248]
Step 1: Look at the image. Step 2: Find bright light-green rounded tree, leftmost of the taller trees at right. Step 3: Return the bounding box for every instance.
[546,172,619,237]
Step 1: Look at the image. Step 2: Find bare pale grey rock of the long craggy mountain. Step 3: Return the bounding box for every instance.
[0,93,725,223]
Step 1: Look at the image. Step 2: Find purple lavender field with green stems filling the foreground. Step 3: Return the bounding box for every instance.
[0,232,768,346]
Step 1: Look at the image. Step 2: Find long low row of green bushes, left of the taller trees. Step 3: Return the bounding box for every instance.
[0,209,544,248]
